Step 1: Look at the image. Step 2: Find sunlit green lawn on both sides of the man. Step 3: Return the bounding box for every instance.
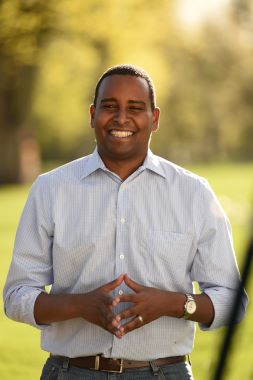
[0,164,253,380]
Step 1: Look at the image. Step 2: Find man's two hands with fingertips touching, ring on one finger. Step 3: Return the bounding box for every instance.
[84,274,170,338]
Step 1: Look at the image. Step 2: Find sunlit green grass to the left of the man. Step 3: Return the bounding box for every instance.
[0,186,47,380]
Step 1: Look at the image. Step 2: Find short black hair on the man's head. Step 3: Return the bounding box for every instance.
[93,64,156,111]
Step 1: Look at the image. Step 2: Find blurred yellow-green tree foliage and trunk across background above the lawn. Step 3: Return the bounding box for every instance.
[0,0,253,182]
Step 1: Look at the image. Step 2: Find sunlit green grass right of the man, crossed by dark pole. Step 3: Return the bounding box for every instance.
[186,163,253,380]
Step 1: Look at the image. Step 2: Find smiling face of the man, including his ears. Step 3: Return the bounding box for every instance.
[90,75,159,162]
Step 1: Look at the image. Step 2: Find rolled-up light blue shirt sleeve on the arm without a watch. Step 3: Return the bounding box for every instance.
[3,177,53,329]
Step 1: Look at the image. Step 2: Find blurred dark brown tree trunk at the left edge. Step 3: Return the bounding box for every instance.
[0,66,39,184]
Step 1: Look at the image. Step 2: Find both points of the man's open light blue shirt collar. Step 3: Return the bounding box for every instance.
[82,148,166,178]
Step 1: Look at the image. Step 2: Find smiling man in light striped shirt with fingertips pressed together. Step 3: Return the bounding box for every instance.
[4,65,247,380]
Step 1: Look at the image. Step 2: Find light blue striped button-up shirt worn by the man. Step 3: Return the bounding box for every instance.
[4,150,247,360]
